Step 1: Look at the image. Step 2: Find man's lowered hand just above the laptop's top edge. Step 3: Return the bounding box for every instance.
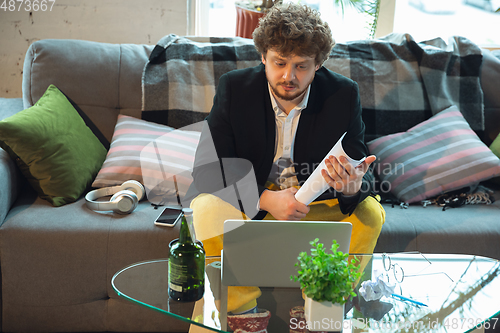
[260,187,309,221]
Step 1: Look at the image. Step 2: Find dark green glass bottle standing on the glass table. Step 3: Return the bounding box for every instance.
[168,208,205,302]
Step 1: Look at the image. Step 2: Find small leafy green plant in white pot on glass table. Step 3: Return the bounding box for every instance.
[290,238,363,329]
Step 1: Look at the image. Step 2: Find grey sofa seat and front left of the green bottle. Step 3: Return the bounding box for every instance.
[0,191,186,332]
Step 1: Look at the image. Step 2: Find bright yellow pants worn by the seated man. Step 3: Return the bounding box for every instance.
[191,194,385,312]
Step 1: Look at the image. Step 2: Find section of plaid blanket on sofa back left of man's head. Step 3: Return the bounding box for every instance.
[142,35,260,128]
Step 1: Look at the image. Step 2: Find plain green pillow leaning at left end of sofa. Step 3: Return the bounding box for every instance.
[0,85,107,206]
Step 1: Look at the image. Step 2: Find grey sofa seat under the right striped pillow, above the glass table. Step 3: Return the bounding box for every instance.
[375,190,500,259]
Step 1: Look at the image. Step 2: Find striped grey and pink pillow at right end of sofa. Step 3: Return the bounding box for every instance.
[368,106,500,203]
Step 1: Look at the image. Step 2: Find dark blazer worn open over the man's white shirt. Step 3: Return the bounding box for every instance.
[193,64,373,216]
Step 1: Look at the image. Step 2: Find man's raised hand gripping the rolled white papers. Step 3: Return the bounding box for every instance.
[321,155,377,195]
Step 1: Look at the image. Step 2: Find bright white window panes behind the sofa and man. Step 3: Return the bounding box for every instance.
[207,0,500,46]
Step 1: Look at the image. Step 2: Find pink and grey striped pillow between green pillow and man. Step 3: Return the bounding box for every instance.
[92,115,199,198]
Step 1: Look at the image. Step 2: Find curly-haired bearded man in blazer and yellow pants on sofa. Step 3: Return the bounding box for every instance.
[191,0,385,322]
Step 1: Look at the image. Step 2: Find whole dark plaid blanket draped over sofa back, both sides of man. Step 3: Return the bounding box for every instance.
[142,34,484,141]
